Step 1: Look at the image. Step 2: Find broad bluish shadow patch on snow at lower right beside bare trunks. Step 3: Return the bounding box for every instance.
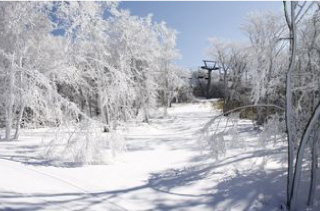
[148,166,285,210]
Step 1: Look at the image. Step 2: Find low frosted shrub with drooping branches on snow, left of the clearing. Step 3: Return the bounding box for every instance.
[44,122,126,165]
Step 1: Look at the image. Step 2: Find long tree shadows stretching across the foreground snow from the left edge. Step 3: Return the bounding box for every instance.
[0,148,285,210]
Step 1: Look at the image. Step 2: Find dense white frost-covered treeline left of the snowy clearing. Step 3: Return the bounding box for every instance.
[0,2,190,140]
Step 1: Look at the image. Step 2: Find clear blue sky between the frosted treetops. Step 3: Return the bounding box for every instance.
[120,1,283,68]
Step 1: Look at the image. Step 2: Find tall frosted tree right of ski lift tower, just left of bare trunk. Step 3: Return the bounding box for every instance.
[241,12,286,107]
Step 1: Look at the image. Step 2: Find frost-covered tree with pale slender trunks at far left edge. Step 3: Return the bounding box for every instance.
[0,2,52,141]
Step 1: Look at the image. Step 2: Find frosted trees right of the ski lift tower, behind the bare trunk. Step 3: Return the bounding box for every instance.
[209,10,320,127]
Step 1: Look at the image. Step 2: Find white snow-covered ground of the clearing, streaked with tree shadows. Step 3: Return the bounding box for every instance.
[0,101,286,211]
